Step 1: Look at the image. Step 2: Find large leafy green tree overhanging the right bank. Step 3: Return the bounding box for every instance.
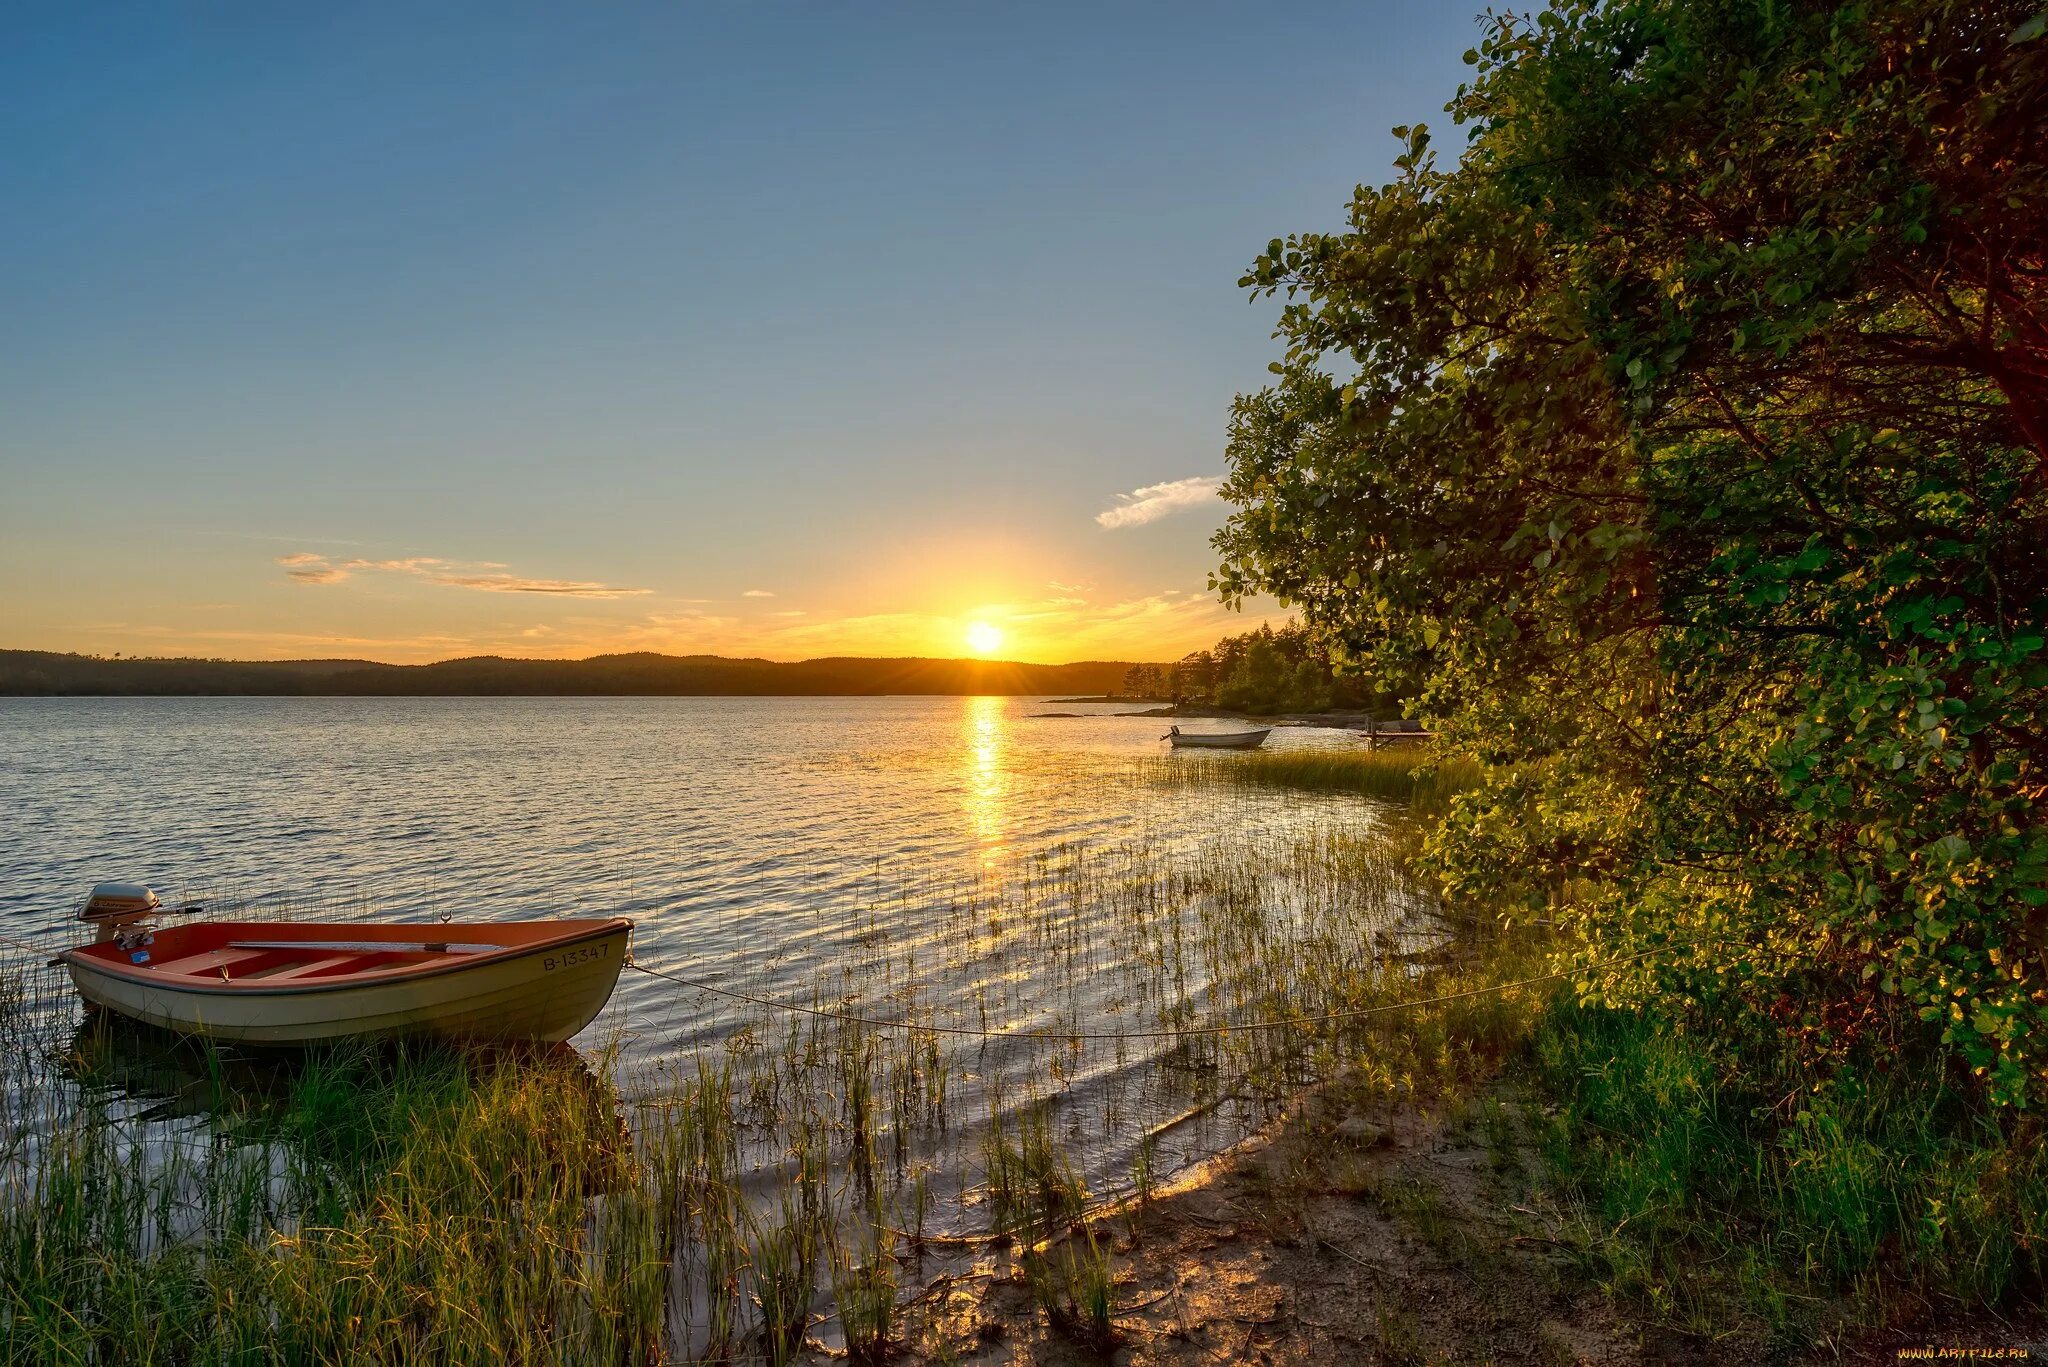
[1217,0,2048,1105]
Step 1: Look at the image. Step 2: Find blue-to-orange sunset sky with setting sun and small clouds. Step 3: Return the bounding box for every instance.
[0,2,1479,662]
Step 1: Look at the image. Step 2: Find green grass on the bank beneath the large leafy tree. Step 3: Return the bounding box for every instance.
[1534,998,2048,1334]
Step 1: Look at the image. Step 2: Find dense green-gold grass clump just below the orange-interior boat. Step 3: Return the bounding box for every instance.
[0,1032,662,1363]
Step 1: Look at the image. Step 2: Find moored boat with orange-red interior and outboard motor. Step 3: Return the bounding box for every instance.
[57,883,633,1047]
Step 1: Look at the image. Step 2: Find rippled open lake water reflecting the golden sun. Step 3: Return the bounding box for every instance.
[0,697,1425,1237]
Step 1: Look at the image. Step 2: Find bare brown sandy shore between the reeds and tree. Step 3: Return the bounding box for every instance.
[903,1084,2048,1367]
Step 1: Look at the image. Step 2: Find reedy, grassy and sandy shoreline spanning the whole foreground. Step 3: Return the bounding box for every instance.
[12,746,2048,1367]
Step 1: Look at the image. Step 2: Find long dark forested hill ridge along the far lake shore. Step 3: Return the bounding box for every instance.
[0,650,1133,697]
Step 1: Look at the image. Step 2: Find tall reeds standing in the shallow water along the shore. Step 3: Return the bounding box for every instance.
[0,778,1458,1365]
